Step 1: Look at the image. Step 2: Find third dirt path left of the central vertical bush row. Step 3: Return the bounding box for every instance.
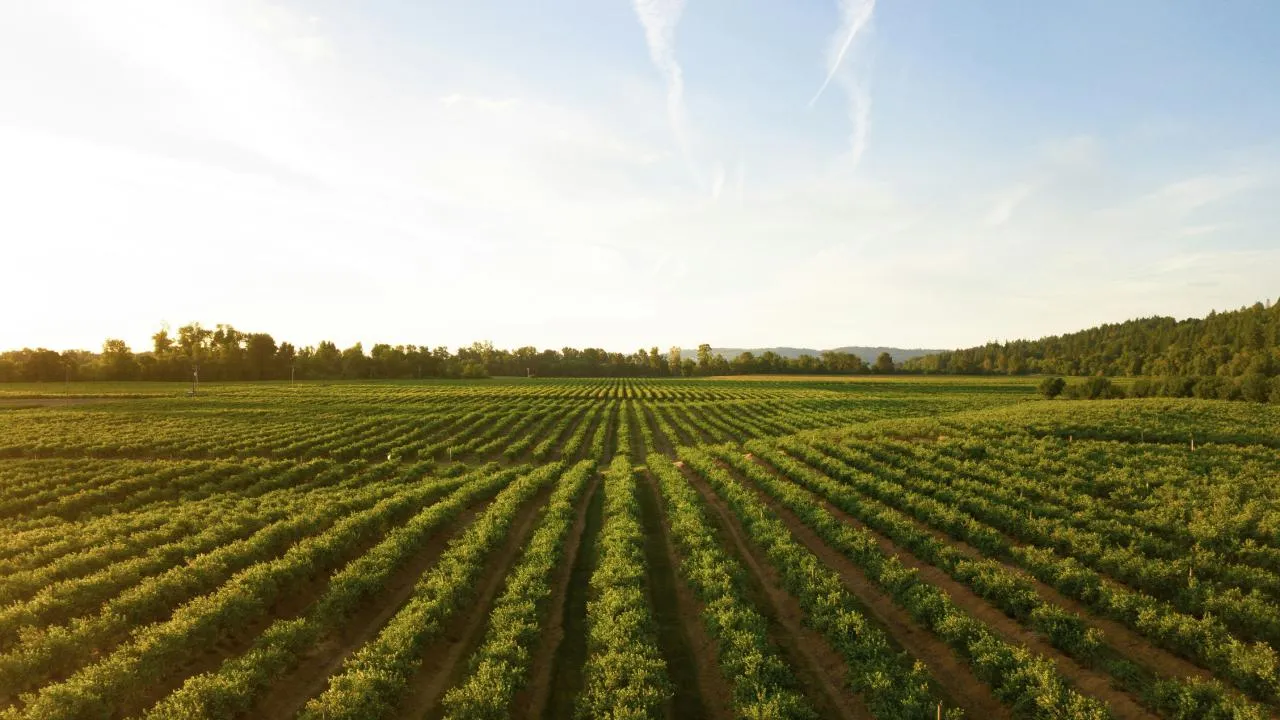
[248,498,492,717]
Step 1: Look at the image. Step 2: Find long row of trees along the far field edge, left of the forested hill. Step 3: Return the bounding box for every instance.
[0,323,893,382]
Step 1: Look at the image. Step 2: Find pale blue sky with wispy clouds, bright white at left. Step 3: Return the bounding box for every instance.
[0,0,1280,351]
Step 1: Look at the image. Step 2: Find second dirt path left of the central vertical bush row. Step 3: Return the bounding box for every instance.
[398,486,553,717]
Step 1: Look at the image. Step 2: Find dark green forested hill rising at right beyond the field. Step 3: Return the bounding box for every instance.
[902,302,1280,377]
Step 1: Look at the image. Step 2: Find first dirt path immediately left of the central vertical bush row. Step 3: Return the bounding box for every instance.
[527,474,604,720]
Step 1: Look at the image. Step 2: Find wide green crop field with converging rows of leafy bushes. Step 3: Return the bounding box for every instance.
[0,377,1280,720]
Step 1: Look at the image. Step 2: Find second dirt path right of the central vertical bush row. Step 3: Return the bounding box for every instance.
[682,468,872,720]
